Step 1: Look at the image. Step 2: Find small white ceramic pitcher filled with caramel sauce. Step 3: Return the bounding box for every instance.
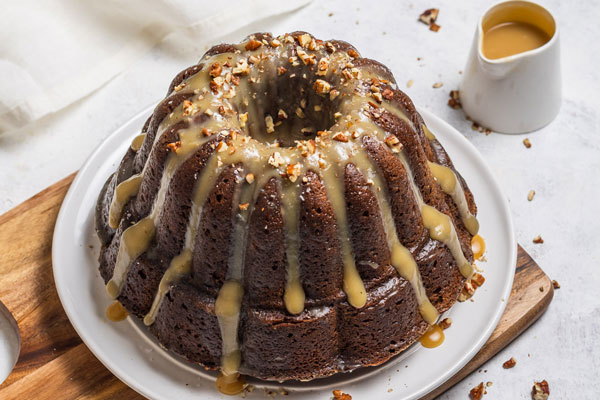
[459,1,561,133]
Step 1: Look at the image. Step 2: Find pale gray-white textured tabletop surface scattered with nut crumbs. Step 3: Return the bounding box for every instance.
[0,0,600,399]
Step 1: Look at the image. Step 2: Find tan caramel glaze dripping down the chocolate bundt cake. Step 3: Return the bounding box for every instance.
[107,34,476,384]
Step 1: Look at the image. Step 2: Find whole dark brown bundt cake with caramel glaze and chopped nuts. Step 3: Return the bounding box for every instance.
[96,32,478,394]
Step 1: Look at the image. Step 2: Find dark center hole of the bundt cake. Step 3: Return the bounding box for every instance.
[248,73,335,147]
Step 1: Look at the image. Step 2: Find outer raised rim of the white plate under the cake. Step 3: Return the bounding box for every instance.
[52,103,517,399]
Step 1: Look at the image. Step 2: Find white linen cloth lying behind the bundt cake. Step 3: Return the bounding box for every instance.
[0,0,310,134]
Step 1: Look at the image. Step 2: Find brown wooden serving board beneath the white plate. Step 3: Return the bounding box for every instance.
[0,174,553,400]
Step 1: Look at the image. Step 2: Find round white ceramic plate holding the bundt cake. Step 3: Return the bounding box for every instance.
[52,109,517,400]
